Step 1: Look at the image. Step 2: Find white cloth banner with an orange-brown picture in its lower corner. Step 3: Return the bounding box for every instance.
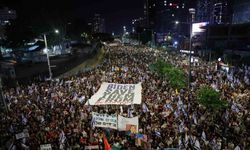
[118,115,139,133]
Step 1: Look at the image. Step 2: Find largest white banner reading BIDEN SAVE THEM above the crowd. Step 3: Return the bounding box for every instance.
[85,82,142,105]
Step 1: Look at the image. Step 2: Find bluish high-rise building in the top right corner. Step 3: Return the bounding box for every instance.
[233,0,250,24]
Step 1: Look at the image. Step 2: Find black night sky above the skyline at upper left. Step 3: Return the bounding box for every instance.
[0,0,144,33]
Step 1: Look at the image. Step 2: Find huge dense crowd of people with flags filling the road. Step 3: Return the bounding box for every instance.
[0,46,250,150]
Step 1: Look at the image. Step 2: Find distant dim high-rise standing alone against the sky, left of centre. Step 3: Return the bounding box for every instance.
[92,14,105,33]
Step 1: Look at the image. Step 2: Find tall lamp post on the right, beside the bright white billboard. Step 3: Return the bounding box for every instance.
[188,8,195,91]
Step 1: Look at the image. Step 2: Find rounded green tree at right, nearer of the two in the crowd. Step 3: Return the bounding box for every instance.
[197,85,228,110]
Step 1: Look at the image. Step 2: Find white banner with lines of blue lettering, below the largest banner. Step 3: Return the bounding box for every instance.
[92,112,117,129]
